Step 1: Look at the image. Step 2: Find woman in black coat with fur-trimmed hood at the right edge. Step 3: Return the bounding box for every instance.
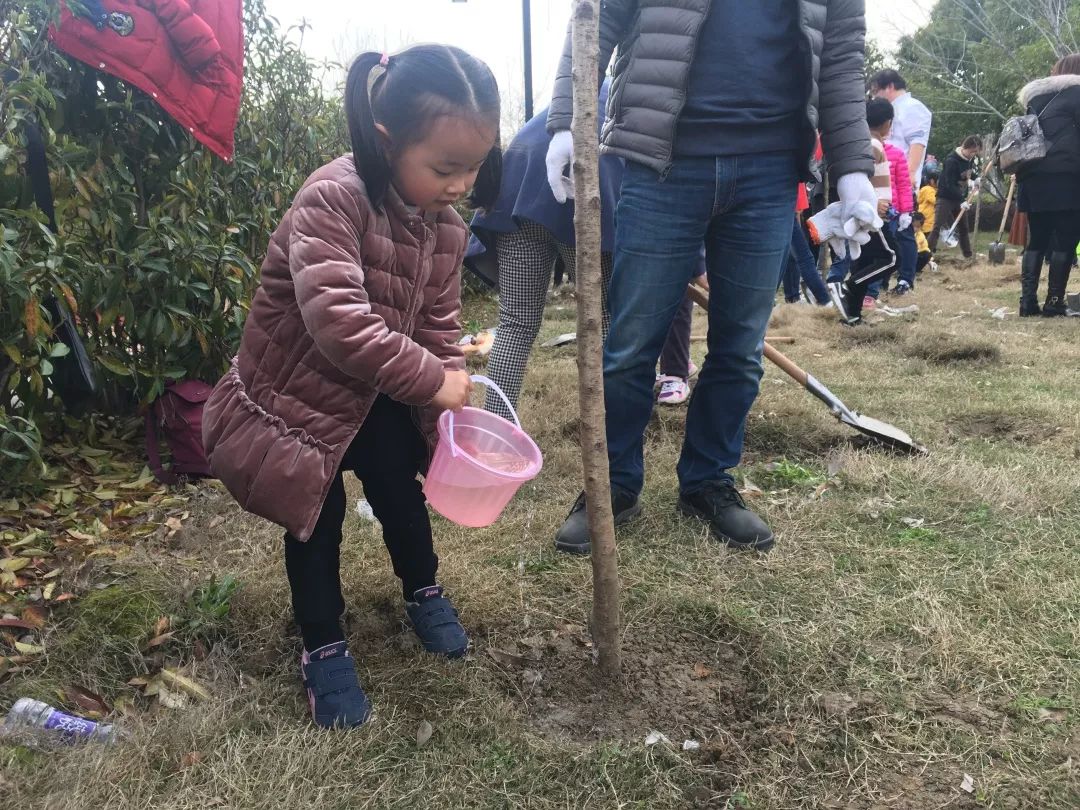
[1017,53,1080,316]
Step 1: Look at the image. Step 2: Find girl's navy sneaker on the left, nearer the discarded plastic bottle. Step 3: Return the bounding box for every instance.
[300,642,372,728]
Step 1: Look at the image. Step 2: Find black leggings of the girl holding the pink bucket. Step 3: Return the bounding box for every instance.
[285,395,438,651]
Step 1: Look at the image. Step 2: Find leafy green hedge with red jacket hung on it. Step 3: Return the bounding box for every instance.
[0,0,347,438]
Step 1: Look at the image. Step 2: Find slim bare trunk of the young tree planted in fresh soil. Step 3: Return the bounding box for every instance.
[572,0,622,676]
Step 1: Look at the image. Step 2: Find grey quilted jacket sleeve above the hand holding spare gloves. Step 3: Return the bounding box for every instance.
[818,0,874,177]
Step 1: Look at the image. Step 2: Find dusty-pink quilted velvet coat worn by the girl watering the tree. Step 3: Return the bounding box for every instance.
[203,157,467,540]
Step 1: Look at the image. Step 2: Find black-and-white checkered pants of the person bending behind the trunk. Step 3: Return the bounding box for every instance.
[484,219,611,419]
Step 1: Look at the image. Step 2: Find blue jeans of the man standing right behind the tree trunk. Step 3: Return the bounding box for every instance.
[604,152,798,496]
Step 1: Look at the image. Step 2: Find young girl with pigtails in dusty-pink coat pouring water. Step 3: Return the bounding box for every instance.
[203,45,500,727]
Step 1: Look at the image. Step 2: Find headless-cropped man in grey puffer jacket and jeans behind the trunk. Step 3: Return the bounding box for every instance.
[548,0,880,553]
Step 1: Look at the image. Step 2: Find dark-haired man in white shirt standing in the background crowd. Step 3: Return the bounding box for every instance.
[870,70,933,295]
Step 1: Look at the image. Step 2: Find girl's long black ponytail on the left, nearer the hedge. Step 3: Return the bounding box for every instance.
[345,51,390,208]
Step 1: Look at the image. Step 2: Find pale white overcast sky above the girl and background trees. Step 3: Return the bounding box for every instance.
[267,0,932,115]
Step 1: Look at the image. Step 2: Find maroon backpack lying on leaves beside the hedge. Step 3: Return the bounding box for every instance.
[146,380,213,484]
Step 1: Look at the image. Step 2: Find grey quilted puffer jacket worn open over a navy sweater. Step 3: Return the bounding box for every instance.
[548,0,874,179]
